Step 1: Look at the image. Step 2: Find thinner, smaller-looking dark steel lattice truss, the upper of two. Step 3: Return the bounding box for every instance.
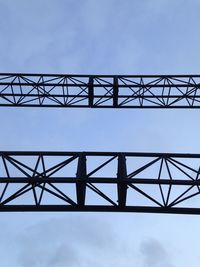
[0,73,200,108]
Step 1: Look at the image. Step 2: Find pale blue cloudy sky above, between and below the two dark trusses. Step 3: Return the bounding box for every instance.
[0,0,200,267]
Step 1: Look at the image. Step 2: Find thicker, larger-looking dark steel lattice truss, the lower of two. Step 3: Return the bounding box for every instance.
[0,152,200,214]
